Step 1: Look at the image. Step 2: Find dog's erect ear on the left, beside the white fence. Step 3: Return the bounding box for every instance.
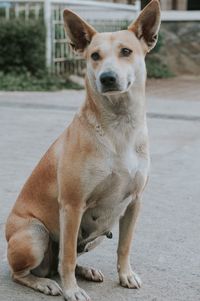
[63,9,96,52]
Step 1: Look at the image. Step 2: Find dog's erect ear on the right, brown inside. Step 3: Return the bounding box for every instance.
[128,0,160,52]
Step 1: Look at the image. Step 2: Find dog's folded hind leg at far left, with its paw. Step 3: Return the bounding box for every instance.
[8,221,62,295]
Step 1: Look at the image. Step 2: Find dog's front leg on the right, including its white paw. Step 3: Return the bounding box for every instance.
[117,198,141,288]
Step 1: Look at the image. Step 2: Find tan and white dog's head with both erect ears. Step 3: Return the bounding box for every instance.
[64,0,160,94]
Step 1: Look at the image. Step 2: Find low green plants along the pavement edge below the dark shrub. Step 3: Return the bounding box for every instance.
[0,72,82,91]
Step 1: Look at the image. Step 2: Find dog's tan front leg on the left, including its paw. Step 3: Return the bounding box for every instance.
[59,202,90,301]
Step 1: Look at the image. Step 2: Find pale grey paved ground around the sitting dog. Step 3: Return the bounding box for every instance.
[0,78,200,301]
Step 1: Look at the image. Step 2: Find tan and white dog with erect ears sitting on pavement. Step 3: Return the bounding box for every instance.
[6,0,160,301]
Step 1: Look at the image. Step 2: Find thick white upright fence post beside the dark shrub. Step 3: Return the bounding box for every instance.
[44,0,52,71]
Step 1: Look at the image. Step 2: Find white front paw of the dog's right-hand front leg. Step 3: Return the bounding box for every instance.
[119,271,142,289]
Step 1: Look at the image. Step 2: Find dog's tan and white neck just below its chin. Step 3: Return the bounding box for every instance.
[83,78,146,130]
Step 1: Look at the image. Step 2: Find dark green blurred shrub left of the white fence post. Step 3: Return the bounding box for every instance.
[0,19,45,75]
